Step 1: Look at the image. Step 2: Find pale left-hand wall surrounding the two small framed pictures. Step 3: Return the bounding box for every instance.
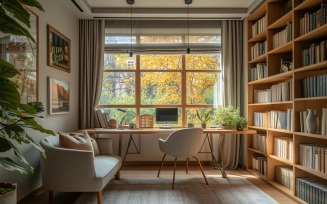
[0,0,79,199]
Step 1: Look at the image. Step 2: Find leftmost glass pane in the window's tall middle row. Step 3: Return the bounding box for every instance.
[99,72,135,105]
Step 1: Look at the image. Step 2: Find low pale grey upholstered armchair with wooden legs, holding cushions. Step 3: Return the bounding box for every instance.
[41,136,121,204]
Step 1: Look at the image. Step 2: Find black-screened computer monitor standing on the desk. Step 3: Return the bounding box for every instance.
[156,108,178,129]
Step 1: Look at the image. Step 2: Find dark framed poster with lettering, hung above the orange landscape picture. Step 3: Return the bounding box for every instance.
[48,25,70,72]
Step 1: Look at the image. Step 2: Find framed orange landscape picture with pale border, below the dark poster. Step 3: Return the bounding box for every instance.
[48,77,70,115]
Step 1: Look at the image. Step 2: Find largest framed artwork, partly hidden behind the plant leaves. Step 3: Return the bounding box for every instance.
[0,9,39,103]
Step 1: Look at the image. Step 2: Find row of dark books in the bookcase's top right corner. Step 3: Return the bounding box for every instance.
[300,3,327,35]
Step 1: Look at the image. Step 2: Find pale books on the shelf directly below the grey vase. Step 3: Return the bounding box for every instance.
[300,144,327,173]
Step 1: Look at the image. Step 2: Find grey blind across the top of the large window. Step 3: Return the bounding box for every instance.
[105,20,221,54]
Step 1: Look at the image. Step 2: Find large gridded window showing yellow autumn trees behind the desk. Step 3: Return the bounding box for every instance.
[99,20,222,126]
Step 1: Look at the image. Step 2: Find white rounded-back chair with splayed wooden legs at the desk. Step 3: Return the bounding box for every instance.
[157,128,208,189]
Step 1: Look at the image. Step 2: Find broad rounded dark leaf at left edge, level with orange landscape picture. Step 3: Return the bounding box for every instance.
[0,81,20,109]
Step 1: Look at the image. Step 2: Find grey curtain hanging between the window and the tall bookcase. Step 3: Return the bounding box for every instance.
[219,20,245,168]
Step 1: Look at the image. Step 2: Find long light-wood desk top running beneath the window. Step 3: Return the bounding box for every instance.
[86,128,257,135]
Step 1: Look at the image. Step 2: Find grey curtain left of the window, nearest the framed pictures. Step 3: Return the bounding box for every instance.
[79,20,105,129]
